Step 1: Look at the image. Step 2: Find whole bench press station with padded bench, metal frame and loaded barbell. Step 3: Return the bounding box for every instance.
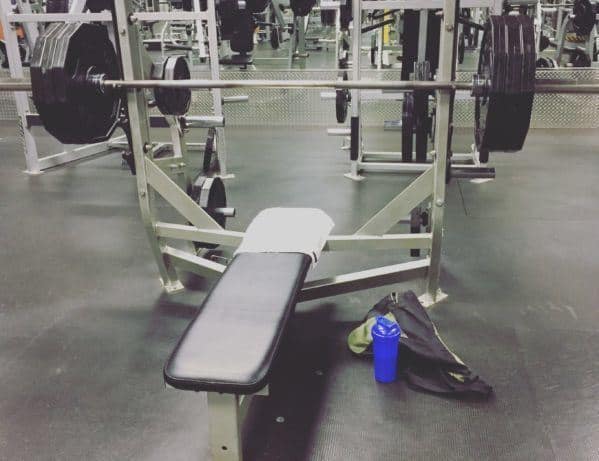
[0,0,599,461]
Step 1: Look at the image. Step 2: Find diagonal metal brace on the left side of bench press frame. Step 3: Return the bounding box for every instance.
[145,158,222,229]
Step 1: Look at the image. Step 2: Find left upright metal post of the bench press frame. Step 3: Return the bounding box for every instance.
[113,0,183,292]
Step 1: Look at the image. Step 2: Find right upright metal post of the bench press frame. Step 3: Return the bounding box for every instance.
[421,0,460,305]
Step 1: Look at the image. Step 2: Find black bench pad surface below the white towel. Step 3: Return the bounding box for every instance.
[164,253,311,394]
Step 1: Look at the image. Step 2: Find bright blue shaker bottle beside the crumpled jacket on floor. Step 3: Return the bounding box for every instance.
[372,316,401,383]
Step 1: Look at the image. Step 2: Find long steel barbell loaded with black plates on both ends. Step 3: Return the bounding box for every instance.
[0,16,599,153]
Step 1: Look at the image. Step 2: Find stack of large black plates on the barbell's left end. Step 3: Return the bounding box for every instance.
[31,23,121,144]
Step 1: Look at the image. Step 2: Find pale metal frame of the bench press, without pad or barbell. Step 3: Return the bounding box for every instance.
[115,0,459,454]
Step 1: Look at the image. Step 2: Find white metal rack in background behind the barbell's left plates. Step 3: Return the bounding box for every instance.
[0,0,236,178]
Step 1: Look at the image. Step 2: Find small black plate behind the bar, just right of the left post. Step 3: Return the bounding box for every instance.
[154,56,191,115]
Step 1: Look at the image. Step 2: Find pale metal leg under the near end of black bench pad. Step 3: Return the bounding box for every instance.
[208,392,243,461]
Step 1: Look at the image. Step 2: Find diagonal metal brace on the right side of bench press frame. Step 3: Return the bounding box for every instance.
[356,167,434,235]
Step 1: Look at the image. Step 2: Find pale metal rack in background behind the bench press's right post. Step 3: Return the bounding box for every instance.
[322,0,502,180]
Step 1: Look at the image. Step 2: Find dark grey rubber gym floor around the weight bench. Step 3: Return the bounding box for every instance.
[0,126,599,461]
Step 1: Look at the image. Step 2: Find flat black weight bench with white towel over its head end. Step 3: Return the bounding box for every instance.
[164,208,333,461]
